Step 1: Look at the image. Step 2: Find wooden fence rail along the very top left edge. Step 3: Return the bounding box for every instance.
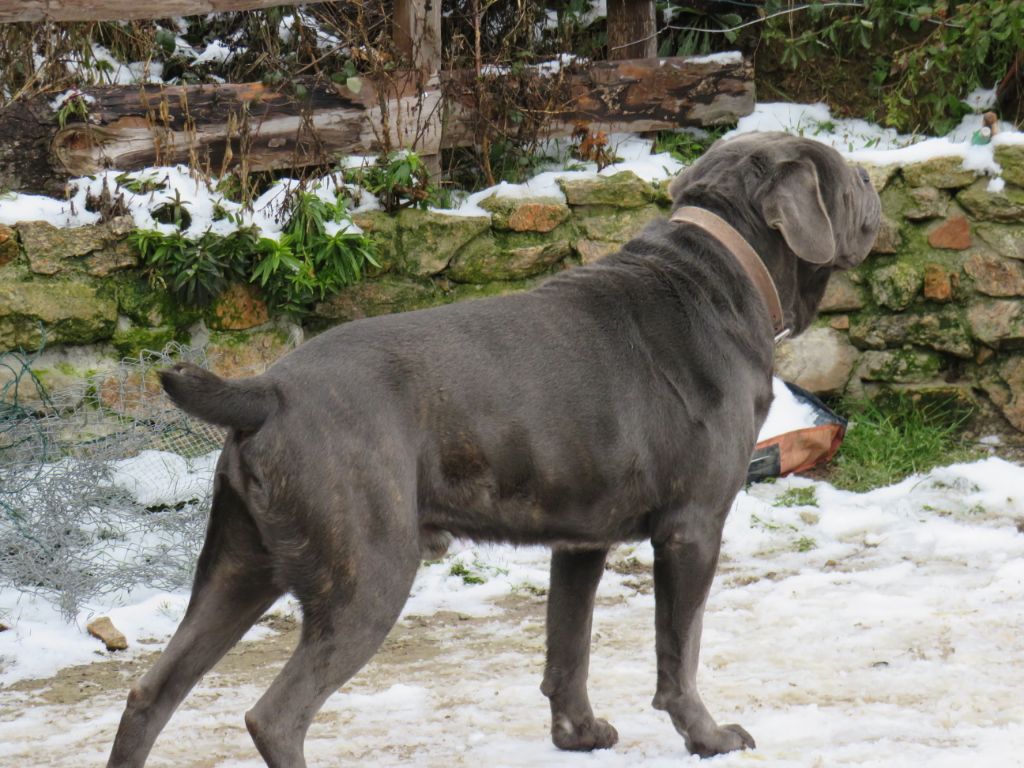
[0,0,315,24]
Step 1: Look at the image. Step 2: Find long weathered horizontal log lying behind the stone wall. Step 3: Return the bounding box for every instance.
[0,54,754,191]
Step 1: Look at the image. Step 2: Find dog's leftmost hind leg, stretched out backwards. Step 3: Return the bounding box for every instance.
[108,477,282,768]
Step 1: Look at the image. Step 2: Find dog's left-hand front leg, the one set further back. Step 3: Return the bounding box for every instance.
[541,549,618,751]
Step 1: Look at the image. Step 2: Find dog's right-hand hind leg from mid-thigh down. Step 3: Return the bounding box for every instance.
[246,505,420,768]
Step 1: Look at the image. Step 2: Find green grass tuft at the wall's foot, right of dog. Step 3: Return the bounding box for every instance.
[829,395,976,490]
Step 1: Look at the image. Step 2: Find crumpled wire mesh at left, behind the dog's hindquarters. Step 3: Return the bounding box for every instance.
[0,343,224,618]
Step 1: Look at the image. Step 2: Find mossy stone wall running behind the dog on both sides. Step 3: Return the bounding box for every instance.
[6,146,1024,430]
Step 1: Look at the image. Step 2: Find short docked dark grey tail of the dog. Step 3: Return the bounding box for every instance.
[160,362,281,432]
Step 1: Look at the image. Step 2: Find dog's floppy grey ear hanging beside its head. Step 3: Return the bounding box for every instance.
[761,160,836,264]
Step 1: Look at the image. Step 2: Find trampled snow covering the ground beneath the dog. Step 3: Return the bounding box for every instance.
[0,387,1024,768]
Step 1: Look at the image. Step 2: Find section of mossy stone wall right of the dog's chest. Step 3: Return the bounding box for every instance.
[777,145,1024,430]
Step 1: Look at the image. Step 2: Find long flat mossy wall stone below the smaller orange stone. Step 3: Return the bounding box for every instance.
[850,306,974,358]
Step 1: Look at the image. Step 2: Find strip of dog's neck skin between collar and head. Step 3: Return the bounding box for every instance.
[673,184,835,336]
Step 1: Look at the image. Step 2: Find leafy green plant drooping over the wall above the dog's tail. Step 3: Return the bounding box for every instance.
[132,191,380,315]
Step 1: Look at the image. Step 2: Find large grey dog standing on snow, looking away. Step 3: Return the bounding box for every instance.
[109,134,880,768]
